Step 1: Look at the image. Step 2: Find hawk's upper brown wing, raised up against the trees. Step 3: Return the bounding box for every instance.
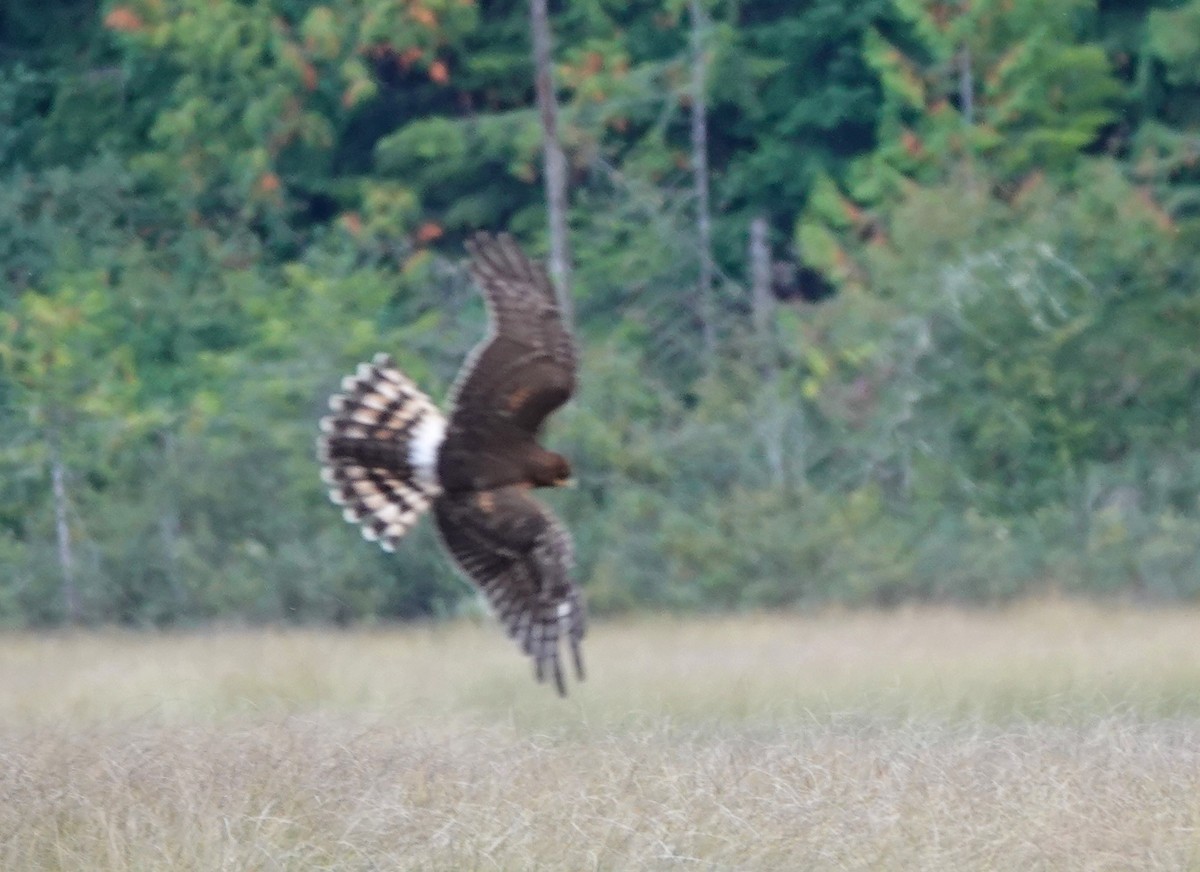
[451,233,576,438]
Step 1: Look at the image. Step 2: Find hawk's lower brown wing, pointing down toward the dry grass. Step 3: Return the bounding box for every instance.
[433,486,584,696]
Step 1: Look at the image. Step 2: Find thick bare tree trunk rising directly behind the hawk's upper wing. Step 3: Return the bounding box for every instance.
[529,0,571,321]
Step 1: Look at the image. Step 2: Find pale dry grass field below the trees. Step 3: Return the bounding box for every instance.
[0,602,1200,872]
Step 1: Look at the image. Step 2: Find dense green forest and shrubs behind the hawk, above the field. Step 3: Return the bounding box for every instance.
[0,0,1200,624]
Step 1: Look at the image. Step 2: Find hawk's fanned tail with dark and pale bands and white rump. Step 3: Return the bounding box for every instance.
[317,354,446,551]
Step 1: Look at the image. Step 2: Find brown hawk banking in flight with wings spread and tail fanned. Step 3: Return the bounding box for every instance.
[318,233,584,696]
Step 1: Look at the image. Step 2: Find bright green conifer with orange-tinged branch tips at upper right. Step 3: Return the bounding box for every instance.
[796,0,1121,293]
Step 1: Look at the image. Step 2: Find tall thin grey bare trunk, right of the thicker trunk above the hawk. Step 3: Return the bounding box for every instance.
[688,0,716,367]
